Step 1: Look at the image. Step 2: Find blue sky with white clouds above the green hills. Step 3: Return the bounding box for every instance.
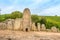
[0,0,60,16]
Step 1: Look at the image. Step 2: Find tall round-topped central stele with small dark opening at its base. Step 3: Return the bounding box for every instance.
[23,8,31,31]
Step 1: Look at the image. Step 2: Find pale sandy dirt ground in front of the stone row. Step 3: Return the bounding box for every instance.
[0,30,60,40]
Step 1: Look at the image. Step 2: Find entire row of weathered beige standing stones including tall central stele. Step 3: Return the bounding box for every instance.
[0,8,60,32]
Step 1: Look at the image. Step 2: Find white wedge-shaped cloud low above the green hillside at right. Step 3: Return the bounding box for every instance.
[38,5,60,16]
